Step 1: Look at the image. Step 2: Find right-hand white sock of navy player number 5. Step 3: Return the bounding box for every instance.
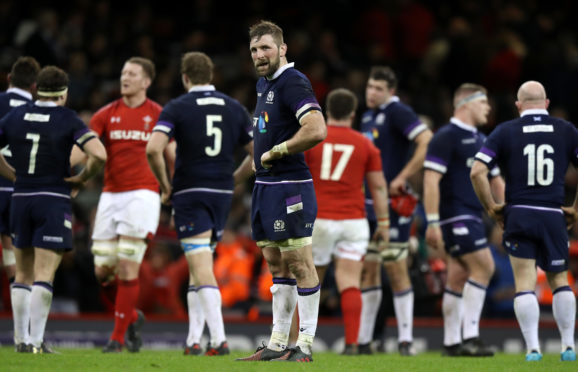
[197,285,226,347]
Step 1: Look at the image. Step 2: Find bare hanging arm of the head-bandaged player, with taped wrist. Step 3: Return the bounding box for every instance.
[423,169,444,249]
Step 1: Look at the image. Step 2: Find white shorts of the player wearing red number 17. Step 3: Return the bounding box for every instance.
[313,218,369,266]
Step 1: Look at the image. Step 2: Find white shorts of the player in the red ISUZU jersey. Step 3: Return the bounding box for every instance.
[92,190,161,240]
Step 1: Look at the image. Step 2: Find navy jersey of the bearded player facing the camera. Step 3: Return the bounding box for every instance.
[253,63,321,182]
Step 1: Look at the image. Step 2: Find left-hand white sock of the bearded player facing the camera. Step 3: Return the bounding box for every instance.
[267,278,297,351]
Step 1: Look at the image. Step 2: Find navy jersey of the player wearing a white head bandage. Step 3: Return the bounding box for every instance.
[424,118,500,220]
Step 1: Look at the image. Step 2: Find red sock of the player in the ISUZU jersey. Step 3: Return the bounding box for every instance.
[110,279,139,345]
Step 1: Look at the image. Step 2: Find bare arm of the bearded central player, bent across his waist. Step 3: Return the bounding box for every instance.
[261,110,327,168]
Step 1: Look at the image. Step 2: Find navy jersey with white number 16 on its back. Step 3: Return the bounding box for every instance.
[476,109,578,208]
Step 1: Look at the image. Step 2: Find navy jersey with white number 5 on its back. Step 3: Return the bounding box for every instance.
[153,85,251,192]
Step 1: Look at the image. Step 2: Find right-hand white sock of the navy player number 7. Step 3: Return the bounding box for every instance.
[30,282,53,347]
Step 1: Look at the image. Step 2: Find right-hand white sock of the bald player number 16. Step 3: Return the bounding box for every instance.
[552,285,576,350]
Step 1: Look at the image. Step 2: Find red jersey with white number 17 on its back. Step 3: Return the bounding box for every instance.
[305,125,381,219]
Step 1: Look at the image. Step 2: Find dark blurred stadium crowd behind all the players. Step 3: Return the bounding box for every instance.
[0,0,578,318]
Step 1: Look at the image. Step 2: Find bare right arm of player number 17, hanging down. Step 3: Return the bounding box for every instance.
[365,170,389,249]
